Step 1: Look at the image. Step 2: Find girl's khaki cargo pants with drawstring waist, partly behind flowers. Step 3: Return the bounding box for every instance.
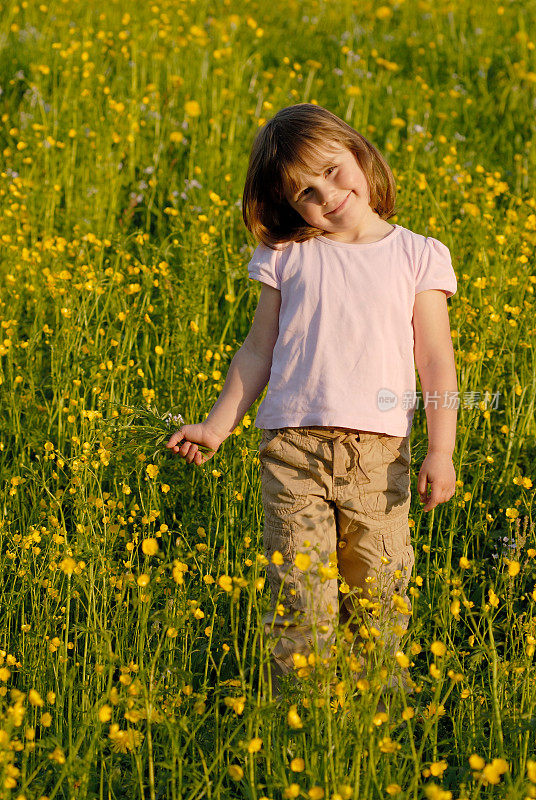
[259,427,415,696]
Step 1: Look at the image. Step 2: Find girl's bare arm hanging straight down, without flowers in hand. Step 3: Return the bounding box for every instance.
[413,289,458,511]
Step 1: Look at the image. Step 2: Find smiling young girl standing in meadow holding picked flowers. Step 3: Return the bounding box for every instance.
[167,103,457,704]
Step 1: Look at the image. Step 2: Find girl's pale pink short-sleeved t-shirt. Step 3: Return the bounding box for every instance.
[248,225,457,436]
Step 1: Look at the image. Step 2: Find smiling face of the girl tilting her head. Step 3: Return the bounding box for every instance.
[286,145,380,239]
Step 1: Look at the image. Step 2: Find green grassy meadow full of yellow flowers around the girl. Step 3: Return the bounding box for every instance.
[0,0,536,800]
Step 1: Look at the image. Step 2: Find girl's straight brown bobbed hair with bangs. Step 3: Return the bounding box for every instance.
[242,103,396,250]
